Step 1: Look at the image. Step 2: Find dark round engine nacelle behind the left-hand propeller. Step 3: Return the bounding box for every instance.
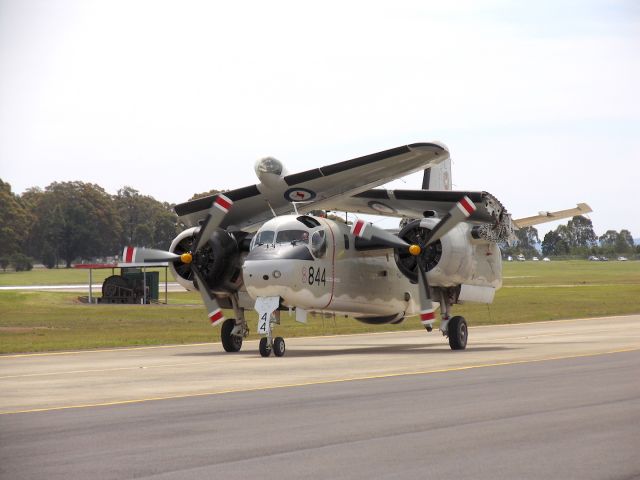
[169,227,247,294]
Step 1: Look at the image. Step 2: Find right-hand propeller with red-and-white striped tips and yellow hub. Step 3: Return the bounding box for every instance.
[351,195,476,329]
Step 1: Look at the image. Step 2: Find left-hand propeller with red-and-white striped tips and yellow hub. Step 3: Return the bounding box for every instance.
[122,194,233,326]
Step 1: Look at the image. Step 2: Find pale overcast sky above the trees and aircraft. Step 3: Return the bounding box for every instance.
[0,0,640,238]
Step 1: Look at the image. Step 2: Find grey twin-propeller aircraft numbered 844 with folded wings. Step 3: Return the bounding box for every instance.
[124,143,591,357]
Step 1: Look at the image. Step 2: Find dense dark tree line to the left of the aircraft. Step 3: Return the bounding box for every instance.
[0,179,220,270]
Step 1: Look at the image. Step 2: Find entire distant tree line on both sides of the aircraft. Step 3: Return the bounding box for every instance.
[0,179,640,270]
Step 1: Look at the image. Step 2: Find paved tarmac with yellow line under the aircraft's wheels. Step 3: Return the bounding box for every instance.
[0,315,640,479]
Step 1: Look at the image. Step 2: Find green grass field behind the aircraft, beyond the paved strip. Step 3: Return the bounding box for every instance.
[0,261,640,353]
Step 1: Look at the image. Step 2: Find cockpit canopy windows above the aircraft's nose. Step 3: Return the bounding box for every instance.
[251,216,327,258]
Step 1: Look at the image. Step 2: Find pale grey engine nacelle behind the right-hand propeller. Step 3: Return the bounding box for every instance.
[395,218,502,289]
